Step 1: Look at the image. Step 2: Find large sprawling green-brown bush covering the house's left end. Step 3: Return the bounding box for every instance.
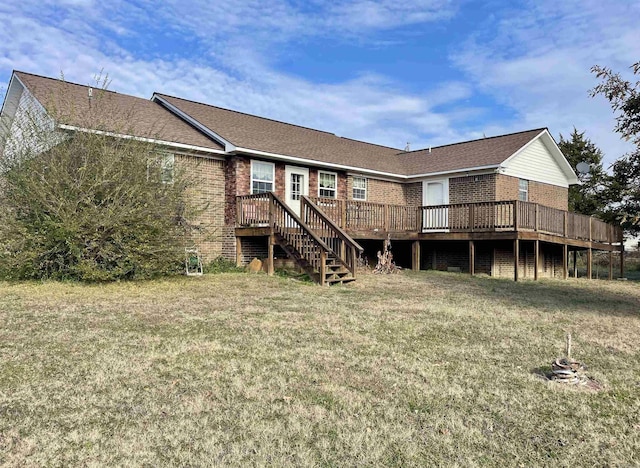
[0,78,205,281]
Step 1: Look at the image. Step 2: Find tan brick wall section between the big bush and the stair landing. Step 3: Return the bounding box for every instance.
[176,154,235,261]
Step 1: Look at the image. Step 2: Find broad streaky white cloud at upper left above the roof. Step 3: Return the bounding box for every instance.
[0,0,470,147]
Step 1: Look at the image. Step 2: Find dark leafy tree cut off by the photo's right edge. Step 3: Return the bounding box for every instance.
[591,62,640,232]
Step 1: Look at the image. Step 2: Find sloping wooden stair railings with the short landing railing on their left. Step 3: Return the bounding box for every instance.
[236,193,363,284]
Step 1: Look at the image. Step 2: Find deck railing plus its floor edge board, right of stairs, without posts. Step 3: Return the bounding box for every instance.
[312,198,622,250]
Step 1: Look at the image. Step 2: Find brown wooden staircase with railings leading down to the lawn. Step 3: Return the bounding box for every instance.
[239,193,363,285]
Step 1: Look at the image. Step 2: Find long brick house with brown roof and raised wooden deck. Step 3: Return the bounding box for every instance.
[1,72,623,283]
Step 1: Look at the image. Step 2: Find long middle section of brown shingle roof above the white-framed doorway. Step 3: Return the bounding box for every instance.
[156,93,403,174]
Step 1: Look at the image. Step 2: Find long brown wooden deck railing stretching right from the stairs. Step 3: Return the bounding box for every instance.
[312,198,621,244]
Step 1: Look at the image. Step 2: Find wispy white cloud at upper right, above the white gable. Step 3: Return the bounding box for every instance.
[453,0,640,167]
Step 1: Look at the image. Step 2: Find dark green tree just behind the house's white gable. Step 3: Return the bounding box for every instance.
[558,128,608,216]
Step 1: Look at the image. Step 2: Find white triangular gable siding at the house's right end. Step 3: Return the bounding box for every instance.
[503,138,569,187]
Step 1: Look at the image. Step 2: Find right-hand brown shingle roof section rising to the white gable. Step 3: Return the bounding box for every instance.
[400,128,545,174]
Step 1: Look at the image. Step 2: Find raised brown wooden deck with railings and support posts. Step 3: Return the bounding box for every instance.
[236,196,624,281]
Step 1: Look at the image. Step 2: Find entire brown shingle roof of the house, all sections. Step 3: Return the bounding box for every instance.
[8,71,545,176]
